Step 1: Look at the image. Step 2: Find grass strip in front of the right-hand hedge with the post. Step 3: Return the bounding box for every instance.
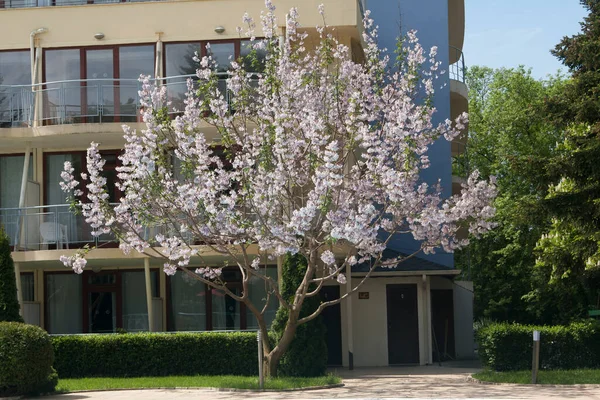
[473,369,600,385]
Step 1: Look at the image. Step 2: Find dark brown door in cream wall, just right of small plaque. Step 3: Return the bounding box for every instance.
[386,285,419,365]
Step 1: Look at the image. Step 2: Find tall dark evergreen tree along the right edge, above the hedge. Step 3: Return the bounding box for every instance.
[533,0,600,317]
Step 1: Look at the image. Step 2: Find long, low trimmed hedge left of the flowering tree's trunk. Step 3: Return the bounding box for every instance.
[52,332,258,378]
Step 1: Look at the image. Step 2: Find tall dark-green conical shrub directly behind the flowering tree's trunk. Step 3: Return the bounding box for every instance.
[271,254,327,377]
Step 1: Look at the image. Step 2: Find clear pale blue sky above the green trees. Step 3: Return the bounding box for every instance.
[463,0,586,78]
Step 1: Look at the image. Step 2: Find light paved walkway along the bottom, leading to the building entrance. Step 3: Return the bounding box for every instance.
[36,366,600,400]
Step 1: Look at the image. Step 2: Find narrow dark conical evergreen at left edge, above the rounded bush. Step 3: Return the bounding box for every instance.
[0,226,23,322]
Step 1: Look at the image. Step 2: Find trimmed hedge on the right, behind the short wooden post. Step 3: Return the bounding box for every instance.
[477,321,600,371]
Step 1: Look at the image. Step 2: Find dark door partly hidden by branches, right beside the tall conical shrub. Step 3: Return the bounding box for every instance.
[320,286,342,366]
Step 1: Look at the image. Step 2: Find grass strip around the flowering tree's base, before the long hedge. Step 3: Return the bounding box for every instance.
[56,375,342,392]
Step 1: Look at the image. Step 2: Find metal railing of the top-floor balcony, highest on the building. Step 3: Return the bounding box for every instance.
[0,72,244,128]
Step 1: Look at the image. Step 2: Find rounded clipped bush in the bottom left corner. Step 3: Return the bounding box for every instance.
[0,322,58,397]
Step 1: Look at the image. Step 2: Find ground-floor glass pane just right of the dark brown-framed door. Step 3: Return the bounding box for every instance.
[121,271,158,332]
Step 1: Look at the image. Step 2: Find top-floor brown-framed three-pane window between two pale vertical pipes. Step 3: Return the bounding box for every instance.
[44,45,155,124]
